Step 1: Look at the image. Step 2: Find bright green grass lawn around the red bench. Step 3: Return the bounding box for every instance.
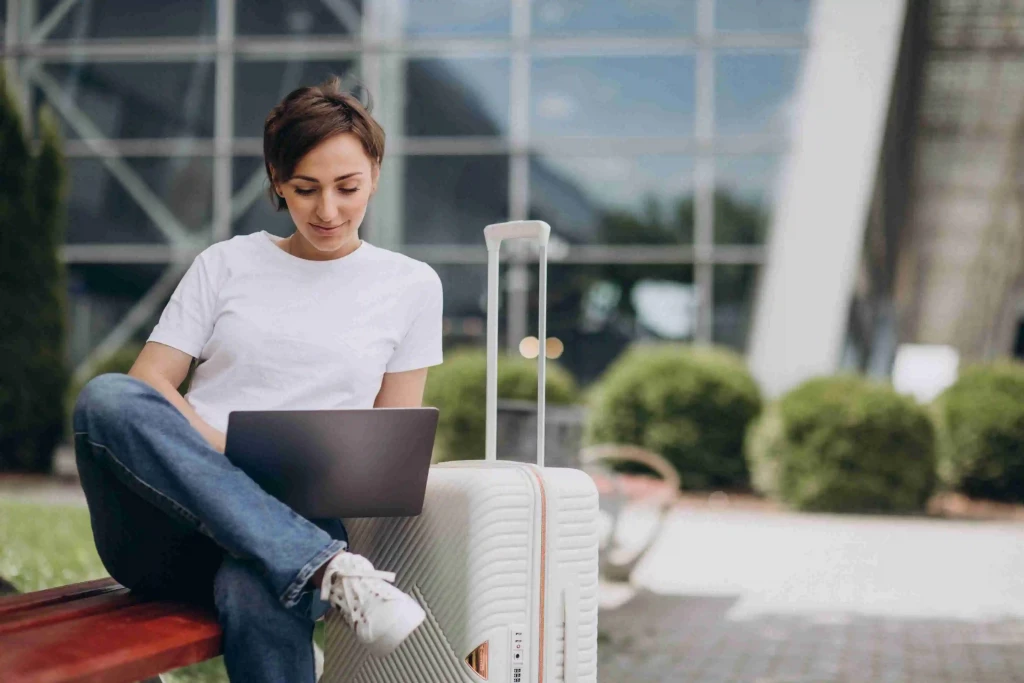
[0,500,227,683]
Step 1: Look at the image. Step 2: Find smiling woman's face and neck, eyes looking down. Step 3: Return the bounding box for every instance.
[274,133,380,260]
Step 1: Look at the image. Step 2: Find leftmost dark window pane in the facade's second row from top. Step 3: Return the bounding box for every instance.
[36,59,214,139]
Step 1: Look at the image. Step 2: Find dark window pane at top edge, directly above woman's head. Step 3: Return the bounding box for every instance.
[234,0,362,38]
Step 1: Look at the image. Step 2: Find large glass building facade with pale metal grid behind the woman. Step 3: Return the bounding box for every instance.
[0,0,810,382]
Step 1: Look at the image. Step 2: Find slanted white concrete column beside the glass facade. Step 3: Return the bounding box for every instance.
[750,0,906,395]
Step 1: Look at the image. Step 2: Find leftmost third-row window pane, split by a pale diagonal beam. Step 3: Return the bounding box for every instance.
[67,157,213,244]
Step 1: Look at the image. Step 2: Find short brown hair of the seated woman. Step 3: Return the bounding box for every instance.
[263,76,384,211]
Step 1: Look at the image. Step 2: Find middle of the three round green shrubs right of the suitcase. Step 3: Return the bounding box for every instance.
[746,376,935,512]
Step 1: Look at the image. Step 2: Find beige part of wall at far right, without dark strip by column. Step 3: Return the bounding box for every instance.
[901,0,1024,360]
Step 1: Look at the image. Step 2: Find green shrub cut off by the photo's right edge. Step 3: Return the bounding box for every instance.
[934,362,1024,502]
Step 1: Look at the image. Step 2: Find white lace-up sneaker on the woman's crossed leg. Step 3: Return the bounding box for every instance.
[321,552,426,656]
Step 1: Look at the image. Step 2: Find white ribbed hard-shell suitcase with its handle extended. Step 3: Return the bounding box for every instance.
[321,221,598,683]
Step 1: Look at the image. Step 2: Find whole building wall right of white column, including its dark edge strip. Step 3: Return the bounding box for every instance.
[848,0,1024,375]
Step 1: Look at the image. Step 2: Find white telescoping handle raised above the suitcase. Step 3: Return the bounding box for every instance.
[483,220,551,467]
